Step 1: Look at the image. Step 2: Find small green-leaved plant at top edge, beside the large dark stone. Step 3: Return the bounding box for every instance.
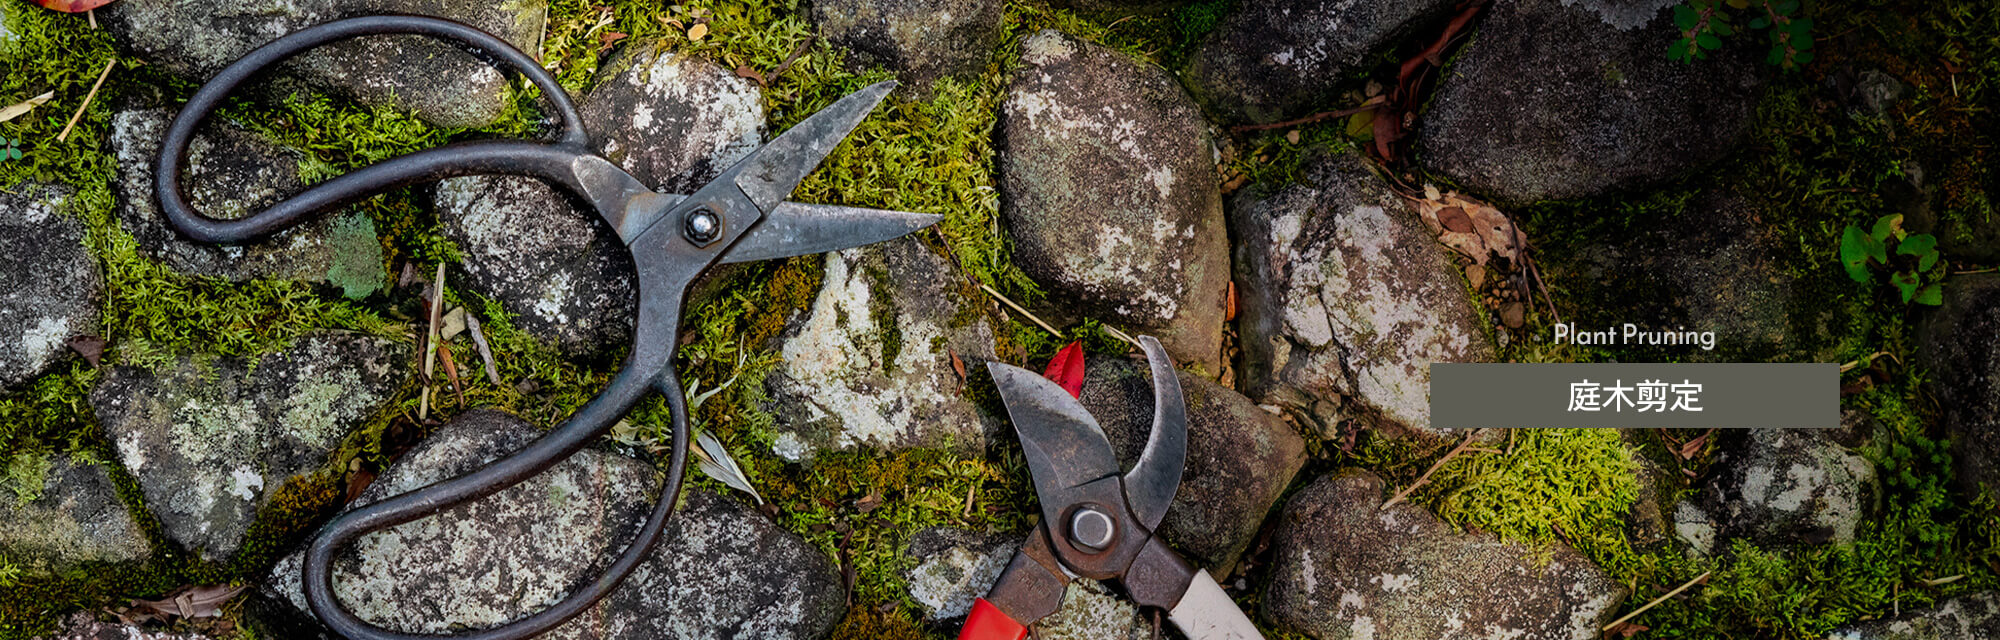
[1666,0,1812,70]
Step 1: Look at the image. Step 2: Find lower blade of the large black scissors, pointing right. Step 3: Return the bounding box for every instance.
[722,202,944,262]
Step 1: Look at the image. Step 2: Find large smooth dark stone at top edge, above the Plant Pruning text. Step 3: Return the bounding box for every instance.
[1414,0,1762,206]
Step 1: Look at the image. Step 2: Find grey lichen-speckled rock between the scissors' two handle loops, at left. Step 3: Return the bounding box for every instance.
[90,332,410,560]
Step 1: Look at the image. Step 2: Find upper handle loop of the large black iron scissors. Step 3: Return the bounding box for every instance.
[154,16,590,244]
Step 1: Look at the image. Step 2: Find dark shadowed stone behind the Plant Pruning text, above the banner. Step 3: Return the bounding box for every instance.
[1538,190,1850,362]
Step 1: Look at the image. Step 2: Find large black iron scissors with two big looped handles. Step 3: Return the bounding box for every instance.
[154,16,940,640]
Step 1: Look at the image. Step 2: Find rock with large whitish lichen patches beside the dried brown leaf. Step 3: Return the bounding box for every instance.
[1230,154,1494,434]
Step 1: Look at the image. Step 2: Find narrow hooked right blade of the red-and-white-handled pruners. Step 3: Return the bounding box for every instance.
[1128,336,1188,528]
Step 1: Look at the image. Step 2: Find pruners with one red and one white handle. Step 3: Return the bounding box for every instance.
[958,336,1264,640]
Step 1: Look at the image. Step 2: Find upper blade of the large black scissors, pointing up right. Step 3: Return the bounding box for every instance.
[730,80,896,214]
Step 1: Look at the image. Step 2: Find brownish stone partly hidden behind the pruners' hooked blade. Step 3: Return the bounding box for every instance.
[1082,358,1306,576]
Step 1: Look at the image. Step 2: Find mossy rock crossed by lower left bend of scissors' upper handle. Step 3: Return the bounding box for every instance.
[112,108,384,298]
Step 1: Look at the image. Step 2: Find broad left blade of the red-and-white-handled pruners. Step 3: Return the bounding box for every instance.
[986,362,1118,496]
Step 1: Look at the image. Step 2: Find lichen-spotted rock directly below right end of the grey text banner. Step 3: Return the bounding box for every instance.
[1674,428,1880,554]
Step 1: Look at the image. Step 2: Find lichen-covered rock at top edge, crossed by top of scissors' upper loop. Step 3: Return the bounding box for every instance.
[98,0,548,126]
